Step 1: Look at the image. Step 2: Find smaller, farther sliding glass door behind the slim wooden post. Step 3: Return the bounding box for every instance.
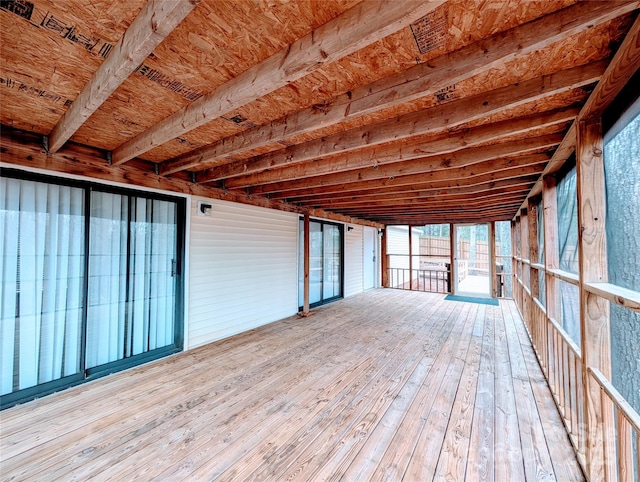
[298,220,343,307]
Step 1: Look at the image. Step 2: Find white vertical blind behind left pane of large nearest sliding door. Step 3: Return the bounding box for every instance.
[0,178,85,394]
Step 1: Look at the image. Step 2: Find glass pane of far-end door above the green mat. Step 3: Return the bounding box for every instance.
[455,224,491,297]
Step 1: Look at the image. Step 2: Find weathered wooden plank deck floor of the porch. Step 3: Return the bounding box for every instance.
[0,290,583,481]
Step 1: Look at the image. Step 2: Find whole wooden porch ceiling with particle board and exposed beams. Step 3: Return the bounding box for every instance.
[0,0,640,225]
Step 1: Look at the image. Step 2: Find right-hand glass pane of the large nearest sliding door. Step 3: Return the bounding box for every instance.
[86,191,177,368]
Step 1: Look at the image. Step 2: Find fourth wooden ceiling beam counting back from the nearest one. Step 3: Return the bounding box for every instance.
[204,61,607,182]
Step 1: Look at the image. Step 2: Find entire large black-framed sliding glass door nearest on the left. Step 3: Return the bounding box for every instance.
[0,170,185,407]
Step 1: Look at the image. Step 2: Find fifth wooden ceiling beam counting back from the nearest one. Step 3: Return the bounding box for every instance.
[225,107,579,189]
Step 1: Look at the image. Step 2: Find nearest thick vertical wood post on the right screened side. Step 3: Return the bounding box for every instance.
[576,118,616,480]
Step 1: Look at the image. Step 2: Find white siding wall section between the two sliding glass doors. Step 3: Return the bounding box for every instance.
[185,197,298,348]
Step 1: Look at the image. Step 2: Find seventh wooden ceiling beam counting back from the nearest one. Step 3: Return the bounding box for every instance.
[269,161,549,202]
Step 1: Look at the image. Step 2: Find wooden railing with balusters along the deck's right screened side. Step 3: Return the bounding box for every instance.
[514,266,640,482]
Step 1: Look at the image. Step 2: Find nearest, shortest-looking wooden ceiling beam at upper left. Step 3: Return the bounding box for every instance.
[49,0,200,152]
